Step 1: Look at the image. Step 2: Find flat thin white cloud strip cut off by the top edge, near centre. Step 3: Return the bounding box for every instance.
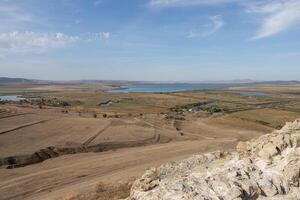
[149,0,237,7]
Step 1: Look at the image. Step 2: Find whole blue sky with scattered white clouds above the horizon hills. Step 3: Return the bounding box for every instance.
[0,0,300,81]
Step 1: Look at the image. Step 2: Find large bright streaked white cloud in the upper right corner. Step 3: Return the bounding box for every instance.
[248,0,300,40]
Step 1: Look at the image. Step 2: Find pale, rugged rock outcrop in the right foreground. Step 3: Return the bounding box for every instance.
[128,120,300,200]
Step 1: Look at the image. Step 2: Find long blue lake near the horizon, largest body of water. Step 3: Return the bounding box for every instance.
[109,83,249,93]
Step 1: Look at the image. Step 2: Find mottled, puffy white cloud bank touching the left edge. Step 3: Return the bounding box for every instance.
[0,32,79,52]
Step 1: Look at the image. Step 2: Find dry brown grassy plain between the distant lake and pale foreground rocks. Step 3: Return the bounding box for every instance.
[0,84,300,200]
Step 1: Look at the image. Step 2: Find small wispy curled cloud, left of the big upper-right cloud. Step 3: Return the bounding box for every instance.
[187,15,225,38]
